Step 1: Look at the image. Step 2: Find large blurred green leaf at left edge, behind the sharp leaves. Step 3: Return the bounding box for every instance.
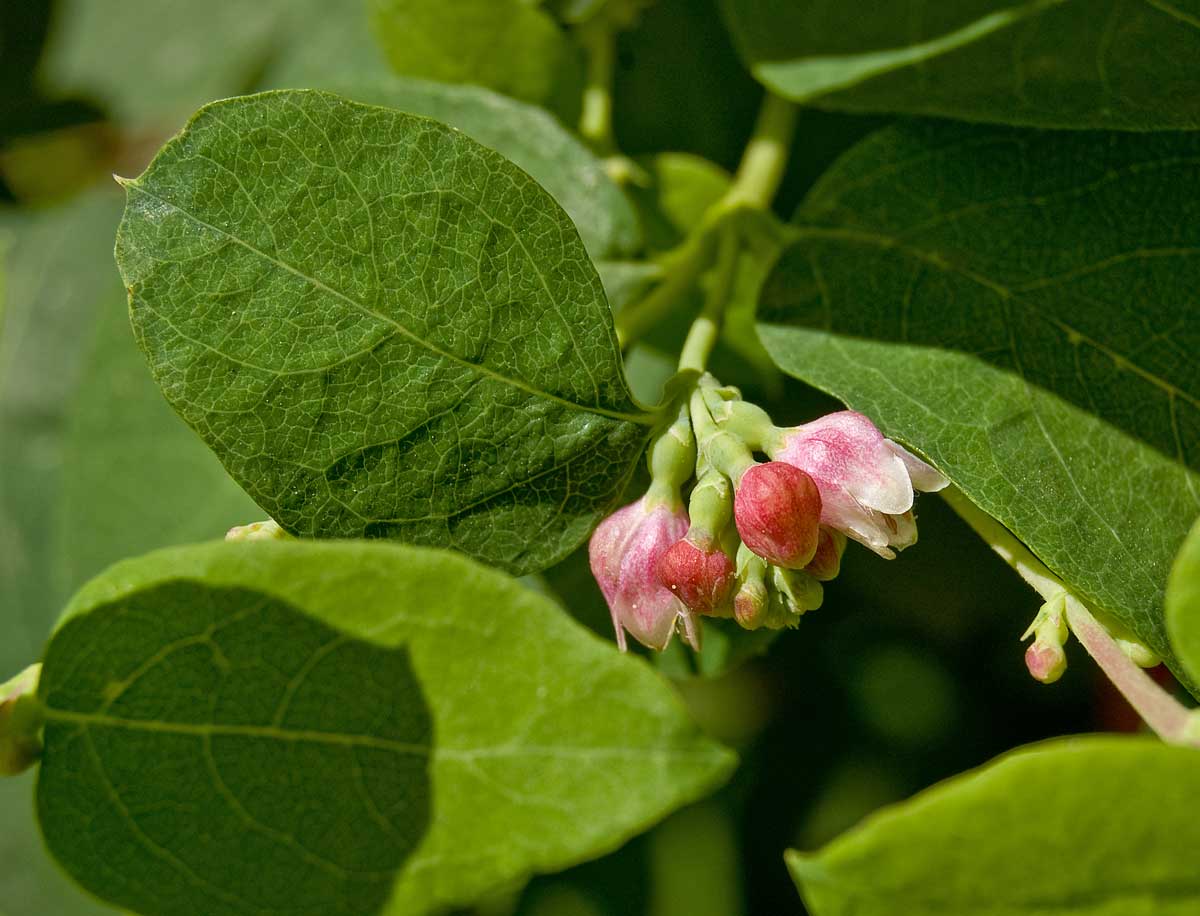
[0,196,260,916]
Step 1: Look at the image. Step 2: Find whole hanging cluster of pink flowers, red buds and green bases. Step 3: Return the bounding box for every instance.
[589,376,947,649]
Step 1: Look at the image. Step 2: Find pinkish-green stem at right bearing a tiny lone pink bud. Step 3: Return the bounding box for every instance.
[942,486,1200,747]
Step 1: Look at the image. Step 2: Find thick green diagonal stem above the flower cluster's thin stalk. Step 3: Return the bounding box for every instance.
[616,92,796,347]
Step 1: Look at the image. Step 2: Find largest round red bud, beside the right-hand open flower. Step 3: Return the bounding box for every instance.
[733,461,821,569]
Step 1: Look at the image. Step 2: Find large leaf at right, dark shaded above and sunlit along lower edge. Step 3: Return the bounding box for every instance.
[760,125,1200,691]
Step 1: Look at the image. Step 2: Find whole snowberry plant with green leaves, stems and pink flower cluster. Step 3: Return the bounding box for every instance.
[0,0,1200,916]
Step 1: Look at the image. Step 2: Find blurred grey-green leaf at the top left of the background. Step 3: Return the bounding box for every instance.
[41,0,385,130]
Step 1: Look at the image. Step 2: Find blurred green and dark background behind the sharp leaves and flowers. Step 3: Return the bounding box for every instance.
[0,0,1133,916]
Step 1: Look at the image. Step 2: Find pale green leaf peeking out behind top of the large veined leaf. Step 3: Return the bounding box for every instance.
[265,72,641,261]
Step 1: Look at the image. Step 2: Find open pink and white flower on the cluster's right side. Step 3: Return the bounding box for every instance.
[770,411,949,559]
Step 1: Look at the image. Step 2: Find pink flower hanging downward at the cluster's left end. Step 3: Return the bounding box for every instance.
[588,496,694,652]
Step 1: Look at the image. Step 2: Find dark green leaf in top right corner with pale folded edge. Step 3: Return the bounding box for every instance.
[724,0,1200,131]
